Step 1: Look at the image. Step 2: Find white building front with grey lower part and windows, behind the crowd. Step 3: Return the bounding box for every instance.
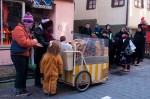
[74,0,150,33]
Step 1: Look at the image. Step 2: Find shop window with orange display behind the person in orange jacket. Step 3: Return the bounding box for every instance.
[0,0,24,47]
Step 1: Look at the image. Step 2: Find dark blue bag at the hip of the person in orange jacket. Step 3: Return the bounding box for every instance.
[10,40,26,54]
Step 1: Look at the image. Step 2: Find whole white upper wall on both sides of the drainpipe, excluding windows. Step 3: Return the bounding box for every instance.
[75,0,150,28]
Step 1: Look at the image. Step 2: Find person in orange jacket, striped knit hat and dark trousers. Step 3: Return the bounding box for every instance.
[11,12,42,95]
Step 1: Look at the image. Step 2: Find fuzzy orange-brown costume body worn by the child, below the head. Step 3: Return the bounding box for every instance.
[40,53,63,94]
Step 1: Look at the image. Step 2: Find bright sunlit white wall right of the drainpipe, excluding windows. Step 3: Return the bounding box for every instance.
[128,0,150,28]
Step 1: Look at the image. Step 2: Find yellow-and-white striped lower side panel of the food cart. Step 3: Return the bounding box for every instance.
[62,63,109,86]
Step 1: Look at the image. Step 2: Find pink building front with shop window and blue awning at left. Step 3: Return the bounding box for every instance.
[0,0,74,65]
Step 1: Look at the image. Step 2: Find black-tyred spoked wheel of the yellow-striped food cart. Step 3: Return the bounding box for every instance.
[75,71,91,92]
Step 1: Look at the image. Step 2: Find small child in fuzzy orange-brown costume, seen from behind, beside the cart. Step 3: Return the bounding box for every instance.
[40,40,63,95]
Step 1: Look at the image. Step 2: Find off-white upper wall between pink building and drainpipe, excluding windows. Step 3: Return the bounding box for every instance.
[75,0,126,25]
